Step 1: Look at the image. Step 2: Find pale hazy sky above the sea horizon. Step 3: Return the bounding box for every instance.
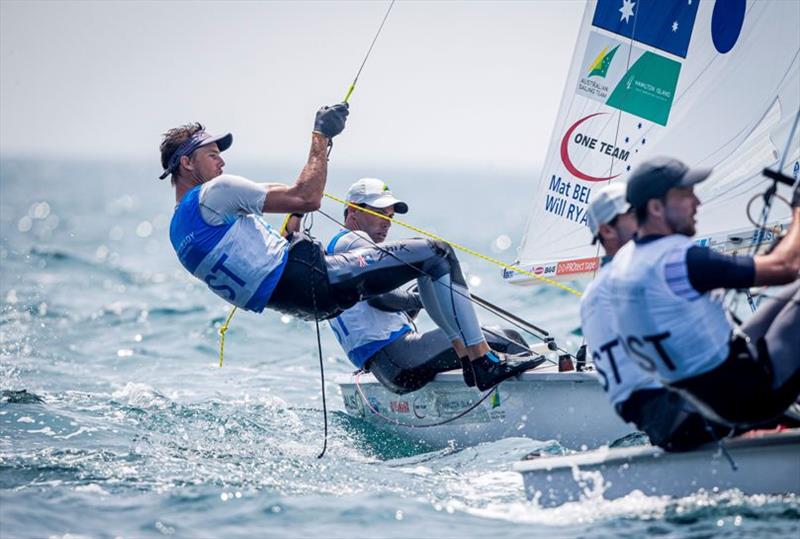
[0,0,584,168]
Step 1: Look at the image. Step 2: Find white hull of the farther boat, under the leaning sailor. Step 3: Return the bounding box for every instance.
[339,372,634,449]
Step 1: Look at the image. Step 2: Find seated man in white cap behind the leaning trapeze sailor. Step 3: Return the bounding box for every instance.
[326,178,535,393]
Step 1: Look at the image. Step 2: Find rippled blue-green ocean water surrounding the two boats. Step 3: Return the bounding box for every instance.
[0,158,800,538]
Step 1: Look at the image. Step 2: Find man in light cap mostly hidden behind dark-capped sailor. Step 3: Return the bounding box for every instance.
[581,182,731,451]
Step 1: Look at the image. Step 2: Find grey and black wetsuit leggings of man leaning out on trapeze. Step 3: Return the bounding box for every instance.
[267,238,484,346]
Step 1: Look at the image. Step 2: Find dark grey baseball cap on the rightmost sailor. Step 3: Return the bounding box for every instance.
[626,157,712,208]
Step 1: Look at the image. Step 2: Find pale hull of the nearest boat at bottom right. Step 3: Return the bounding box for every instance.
[514,429,800,507]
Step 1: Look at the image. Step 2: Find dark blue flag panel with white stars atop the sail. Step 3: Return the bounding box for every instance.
[592,0,700,58]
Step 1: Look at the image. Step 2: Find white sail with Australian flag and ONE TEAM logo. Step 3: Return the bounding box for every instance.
[504,0,800,283]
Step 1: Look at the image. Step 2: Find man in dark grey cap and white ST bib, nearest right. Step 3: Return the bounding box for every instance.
[608,157,800,425]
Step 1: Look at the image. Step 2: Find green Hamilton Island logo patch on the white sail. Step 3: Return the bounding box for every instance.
[606,52,681,125]
